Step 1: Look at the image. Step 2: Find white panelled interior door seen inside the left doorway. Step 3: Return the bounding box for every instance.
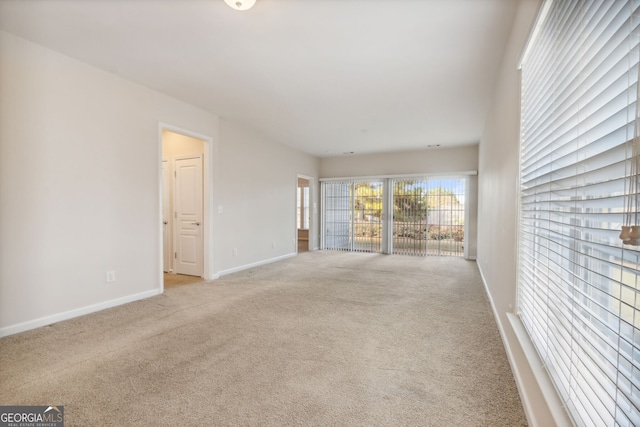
[174,156,203,277]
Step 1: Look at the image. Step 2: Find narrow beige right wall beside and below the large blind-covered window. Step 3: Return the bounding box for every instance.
[477,0,568,426]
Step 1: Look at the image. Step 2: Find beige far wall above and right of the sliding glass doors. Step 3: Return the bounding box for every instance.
[320,145,478,259]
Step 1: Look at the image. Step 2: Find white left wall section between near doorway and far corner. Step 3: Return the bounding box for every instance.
[214,119,318,274]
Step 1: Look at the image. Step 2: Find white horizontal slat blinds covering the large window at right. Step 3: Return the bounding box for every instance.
[518,0,640,426]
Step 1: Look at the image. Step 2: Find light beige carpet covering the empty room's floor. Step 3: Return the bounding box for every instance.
[0,252,526,426]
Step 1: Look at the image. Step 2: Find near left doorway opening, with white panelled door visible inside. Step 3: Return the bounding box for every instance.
[162,129,206,282]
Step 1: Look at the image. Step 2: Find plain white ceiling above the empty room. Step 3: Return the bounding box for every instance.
[0,0,517,156]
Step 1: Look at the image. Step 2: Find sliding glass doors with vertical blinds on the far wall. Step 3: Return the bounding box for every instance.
[322,178,466,256]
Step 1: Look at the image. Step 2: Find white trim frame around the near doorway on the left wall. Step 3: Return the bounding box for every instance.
[157,122,215,292]
